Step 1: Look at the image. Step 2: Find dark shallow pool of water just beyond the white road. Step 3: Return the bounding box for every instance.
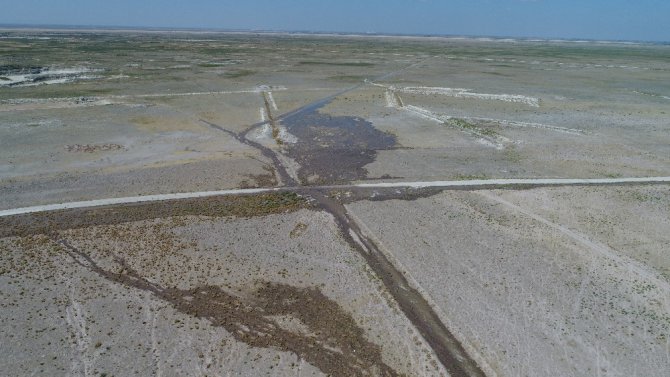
[281,103,396,185]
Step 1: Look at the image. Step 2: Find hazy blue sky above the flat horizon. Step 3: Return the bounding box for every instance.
[0,0,670,41]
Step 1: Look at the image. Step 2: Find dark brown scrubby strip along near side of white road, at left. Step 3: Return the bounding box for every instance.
[0,192,308,238]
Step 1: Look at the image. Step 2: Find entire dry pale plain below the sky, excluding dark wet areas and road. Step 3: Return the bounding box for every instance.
[0,30,670,376]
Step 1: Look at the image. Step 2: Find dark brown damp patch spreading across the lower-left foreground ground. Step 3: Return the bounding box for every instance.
[58,240,399,376]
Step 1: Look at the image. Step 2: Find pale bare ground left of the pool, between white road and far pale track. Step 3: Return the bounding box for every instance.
[0,93,274,208]
